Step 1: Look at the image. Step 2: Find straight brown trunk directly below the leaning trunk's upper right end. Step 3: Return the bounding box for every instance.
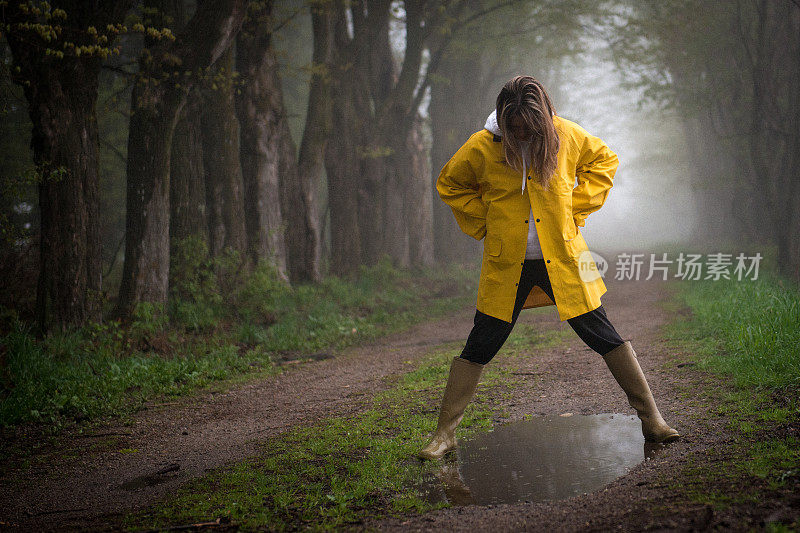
[200,46,247,256]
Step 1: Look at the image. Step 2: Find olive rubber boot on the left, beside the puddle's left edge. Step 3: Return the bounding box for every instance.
[418,357,483,459]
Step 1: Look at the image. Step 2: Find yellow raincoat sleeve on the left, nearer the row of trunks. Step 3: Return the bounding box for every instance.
[436,142,488,240]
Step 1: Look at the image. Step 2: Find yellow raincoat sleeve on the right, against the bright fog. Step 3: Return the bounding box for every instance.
[572,131,619,226]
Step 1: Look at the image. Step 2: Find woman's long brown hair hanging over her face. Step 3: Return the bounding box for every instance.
[496,76,561,189]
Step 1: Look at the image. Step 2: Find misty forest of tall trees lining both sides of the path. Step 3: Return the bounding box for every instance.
[2,1,800,330]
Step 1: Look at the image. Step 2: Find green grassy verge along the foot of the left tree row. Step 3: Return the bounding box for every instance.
[0,263,477,432]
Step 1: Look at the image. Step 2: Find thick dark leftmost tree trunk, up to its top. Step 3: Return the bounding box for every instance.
[0,1,132,331]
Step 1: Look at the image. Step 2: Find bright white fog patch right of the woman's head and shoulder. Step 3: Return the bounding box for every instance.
[552,44,697,252]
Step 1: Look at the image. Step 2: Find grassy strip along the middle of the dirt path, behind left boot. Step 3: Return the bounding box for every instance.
[127,345,519,531]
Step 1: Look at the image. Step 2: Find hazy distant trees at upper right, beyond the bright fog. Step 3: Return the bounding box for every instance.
[604,0,800,280]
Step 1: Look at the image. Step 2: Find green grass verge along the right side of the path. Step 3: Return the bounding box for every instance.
[665,272,800,516]
